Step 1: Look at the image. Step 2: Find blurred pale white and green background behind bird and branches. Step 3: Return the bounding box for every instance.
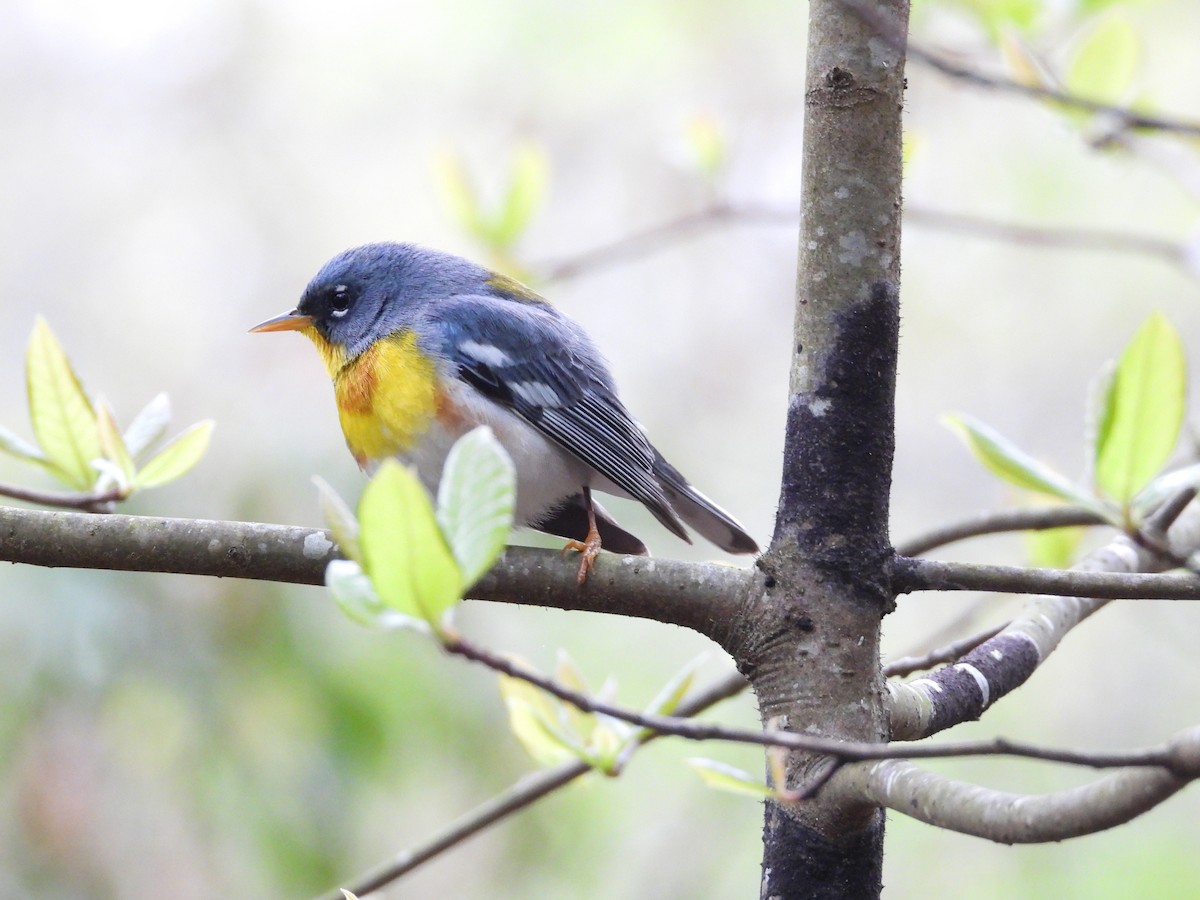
[0,0,1200,899]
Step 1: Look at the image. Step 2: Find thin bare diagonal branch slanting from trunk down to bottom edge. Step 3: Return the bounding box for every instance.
[326,672,749,900]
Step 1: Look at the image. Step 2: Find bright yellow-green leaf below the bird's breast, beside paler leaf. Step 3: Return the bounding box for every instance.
[358,460,462,630]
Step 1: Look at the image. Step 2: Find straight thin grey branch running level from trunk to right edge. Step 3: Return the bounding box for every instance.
[892,557,1200,600]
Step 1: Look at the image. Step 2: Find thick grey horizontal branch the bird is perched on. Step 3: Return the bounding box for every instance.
[0,506,751,636]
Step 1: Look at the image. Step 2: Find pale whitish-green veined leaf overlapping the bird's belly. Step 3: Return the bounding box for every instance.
[438,426,516,589]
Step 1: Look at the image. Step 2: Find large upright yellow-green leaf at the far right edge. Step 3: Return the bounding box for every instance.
[1096,312,1187,509]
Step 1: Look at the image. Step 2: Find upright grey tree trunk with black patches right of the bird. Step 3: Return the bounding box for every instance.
[727,0,907,898]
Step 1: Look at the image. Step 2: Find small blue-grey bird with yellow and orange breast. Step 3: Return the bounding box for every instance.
[251,242,758,586]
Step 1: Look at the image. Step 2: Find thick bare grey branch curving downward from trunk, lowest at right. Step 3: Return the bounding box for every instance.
[838,728,1200,844]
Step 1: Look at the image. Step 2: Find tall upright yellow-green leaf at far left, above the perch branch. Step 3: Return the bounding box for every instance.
[25,318,101,491]
